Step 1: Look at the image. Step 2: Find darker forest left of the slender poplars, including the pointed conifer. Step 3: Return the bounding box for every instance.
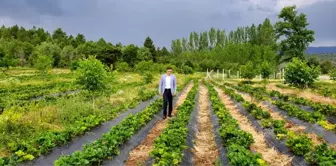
[0,25,170,71]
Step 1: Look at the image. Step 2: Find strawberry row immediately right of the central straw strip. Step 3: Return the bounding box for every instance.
[208,85,267,166]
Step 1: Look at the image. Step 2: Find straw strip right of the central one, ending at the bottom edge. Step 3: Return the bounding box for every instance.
[217,89,292,166]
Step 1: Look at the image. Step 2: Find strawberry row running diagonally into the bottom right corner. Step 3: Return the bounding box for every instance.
[218,84,336,165]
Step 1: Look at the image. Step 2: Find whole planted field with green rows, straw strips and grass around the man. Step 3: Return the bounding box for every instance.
[0,70,336,166]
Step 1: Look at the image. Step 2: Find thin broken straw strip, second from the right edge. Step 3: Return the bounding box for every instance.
[236,91,324,145]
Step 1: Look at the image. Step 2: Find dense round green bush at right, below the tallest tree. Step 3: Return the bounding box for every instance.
[285,58,320,88]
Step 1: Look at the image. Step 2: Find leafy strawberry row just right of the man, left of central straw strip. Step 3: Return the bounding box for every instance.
[150,81,198,166]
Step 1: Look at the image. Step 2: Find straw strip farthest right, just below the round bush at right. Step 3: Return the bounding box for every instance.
[266,83,336,105]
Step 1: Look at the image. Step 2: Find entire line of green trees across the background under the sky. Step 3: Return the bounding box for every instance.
[0,6,334,78]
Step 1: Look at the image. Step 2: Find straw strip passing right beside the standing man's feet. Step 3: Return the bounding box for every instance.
[125,84,193,166]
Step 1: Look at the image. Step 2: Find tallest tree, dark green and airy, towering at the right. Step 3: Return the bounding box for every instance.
[275,6,315,61]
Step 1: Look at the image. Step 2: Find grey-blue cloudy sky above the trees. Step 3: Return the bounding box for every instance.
[0,0,336,47]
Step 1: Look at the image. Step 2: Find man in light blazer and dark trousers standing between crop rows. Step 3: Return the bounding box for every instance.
[159,67,176,119]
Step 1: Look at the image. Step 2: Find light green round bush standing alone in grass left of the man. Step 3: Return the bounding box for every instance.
[76,57,107,91]
